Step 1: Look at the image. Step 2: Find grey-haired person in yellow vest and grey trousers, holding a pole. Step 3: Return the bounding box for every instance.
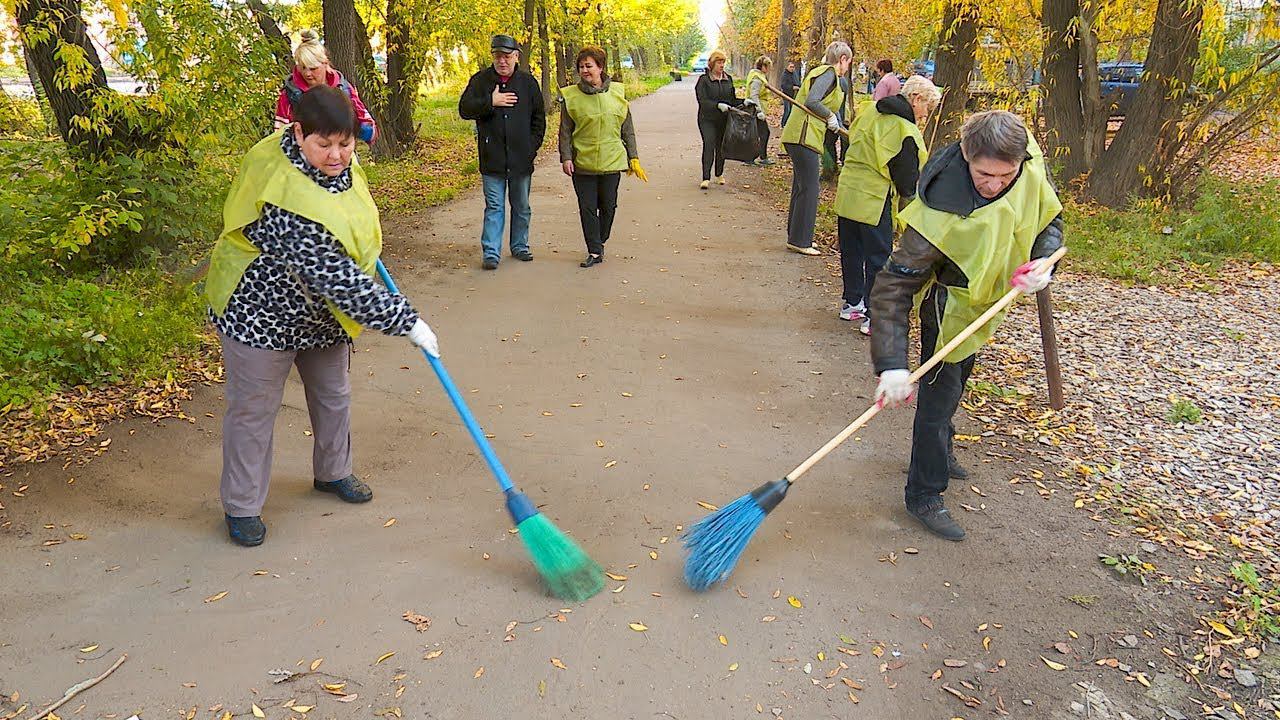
[782,41,854,255]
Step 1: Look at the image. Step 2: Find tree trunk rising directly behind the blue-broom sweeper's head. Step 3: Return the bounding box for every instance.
[924,0,978,147]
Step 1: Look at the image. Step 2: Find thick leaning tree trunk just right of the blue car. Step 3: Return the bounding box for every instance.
[1085,0,1204,208]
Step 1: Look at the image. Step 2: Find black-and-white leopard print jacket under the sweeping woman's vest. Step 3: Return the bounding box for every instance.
[210,132,419,351]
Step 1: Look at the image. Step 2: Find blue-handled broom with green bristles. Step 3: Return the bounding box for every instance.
[378,260,604,602]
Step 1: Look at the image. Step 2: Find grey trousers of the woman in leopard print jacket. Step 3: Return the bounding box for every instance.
[218,333,351,518]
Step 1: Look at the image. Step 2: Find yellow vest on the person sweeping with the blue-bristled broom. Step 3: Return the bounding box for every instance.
[902,138,1062,363]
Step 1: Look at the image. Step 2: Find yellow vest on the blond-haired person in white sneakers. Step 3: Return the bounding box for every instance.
[836,100,928,225]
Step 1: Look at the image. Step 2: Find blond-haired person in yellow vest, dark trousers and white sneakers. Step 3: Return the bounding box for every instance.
[836,76,942,334]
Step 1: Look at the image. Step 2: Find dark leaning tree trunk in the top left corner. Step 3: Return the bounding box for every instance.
[17,0,111,155]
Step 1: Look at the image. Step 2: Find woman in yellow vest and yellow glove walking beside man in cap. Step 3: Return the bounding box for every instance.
[559,46,649,268]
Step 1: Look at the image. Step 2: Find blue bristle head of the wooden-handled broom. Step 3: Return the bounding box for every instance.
[682,478,791,591]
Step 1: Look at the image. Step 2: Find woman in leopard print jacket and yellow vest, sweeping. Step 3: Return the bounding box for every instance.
[205,86,439,546]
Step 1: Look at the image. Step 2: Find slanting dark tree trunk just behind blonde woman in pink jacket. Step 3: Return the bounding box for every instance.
[323,0,408,158]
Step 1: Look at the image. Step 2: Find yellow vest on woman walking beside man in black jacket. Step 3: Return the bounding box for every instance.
[561,82,628,173]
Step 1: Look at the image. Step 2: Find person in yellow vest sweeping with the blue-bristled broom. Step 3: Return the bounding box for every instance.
[870,110,1062,541]
